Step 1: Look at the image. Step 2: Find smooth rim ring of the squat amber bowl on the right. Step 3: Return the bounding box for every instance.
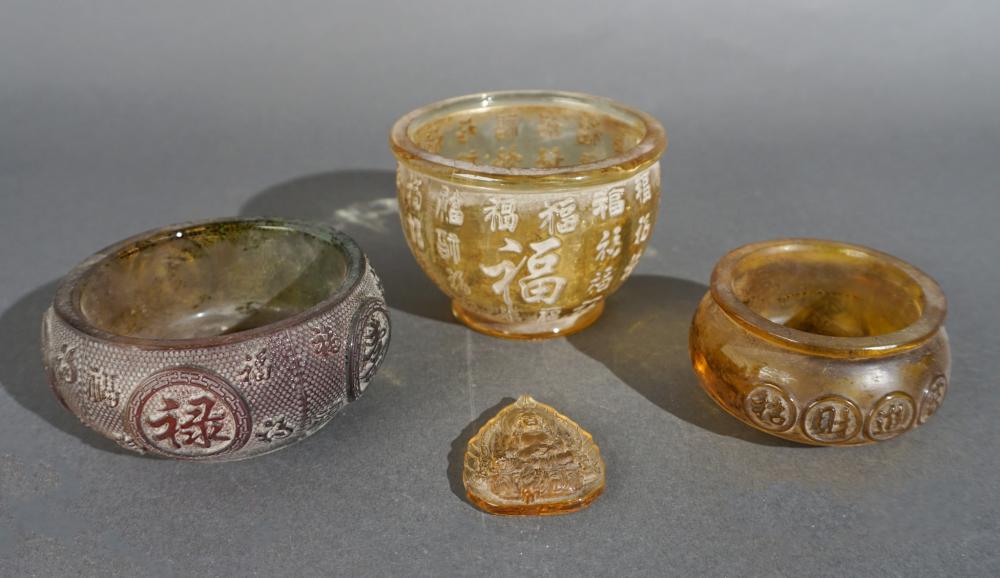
[709,238,948,358]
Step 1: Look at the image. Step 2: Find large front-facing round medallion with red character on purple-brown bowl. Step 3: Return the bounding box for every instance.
[126,367,251,459]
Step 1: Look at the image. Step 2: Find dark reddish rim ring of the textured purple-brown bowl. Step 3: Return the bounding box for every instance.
[52,217,367,350]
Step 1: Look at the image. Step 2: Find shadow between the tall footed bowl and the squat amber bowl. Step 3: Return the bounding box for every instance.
[567,275,806,447]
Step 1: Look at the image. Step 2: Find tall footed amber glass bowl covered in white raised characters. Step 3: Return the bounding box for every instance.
[390,92,666,338]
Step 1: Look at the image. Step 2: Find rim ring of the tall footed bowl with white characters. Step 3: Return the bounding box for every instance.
[389,90,667,186]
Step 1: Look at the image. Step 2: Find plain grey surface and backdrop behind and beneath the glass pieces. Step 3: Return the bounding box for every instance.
[0,0,1000,576]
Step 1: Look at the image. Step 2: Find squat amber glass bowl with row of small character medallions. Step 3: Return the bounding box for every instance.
[690,239,951,445]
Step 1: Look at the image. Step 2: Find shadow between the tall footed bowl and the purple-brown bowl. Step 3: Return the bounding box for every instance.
[240,170,454,323]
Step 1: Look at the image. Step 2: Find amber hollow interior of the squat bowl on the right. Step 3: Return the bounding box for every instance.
[732,245,924,337]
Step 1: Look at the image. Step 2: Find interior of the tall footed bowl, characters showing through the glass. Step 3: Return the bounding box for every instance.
[406,93,646,169]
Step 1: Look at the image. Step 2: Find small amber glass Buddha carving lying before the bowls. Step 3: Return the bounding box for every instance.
[463,395,604,515]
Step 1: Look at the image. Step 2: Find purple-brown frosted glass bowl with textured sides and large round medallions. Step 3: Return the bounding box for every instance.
[42,219,389,460]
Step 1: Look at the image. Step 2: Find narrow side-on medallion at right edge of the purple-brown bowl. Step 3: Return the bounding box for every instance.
[347,299,390,400]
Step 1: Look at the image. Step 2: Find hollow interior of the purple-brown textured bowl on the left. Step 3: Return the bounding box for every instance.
[74,222,348,339]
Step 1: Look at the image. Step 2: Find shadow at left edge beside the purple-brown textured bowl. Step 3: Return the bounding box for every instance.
[0,281,136,456]
